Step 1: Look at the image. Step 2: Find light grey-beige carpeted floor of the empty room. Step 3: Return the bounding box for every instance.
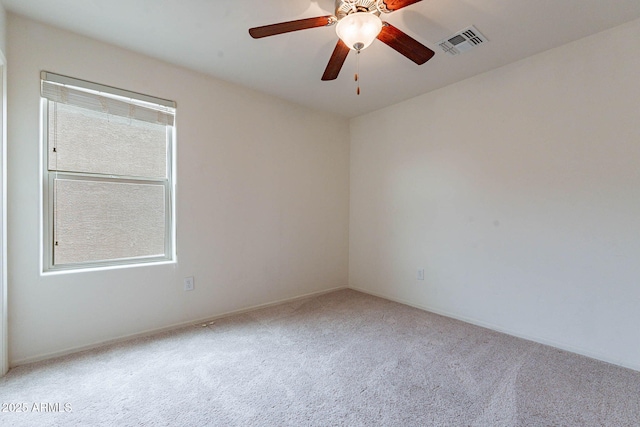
[0,290,640,426]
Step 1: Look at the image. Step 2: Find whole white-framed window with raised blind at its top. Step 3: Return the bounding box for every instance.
[41,72,175,270]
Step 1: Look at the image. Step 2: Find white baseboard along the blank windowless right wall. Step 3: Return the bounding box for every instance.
[349,286,640,372]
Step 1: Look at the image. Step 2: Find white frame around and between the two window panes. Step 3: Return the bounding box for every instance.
[40,71,176,273]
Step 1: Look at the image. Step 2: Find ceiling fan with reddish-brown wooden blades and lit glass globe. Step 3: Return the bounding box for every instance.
[249,0,435,80]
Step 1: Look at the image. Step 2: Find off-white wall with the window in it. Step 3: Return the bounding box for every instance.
[8,14,349,364]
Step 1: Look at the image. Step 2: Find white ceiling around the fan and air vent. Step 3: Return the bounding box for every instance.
[1,0,640,117]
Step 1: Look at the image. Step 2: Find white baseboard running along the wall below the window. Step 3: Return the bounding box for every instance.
[10,286,348,368]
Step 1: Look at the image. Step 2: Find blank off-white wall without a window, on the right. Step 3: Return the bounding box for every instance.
[349,21,640,370]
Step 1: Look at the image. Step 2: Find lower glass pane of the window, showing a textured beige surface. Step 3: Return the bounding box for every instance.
[54,179,166,264]
